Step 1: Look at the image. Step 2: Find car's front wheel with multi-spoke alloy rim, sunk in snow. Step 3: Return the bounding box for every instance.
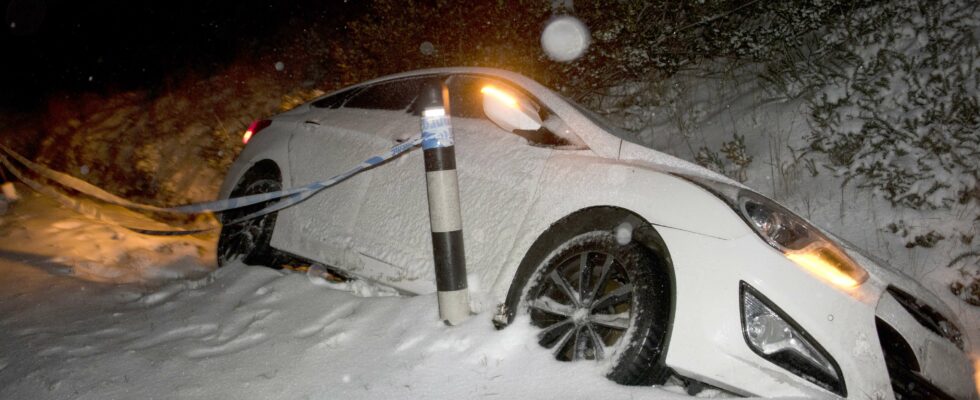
[523,231,670,385]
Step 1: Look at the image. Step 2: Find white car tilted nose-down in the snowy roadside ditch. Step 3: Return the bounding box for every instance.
[218,68,977,399]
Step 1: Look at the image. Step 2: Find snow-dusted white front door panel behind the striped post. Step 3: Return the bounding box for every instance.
[355,111,552,293]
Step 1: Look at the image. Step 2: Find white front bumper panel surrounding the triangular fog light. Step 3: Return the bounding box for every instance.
[660,228,891,398]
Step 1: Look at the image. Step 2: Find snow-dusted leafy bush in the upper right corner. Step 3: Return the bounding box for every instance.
[769,0,980,209]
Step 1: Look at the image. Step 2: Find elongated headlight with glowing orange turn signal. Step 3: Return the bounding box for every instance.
[737,190,868,289]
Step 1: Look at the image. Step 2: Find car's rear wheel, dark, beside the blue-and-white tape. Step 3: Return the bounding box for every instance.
[218,171,282,266]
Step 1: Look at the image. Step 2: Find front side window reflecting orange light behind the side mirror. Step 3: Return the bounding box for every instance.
[446,75,570,147]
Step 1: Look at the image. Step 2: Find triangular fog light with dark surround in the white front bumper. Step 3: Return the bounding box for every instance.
[740,282,847,397]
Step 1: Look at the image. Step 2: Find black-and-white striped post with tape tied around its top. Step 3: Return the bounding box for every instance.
[421,79,470,325]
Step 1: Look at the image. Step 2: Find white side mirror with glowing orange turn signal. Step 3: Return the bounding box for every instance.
[480,85,541,132]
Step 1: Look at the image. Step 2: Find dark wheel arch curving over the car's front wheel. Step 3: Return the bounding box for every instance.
[494,206,677,328]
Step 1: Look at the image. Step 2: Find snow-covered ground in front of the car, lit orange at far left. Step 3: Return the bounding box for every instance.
[0,186,756,399]
